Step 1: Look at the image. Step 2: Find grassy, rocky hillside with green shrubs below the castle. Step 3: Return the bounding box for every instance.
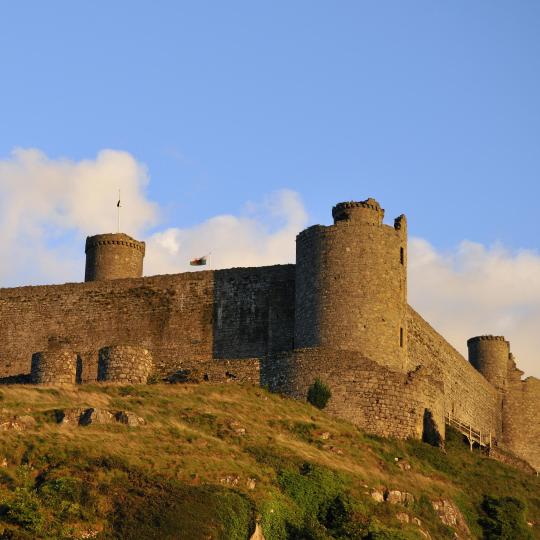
[0,384,540,540]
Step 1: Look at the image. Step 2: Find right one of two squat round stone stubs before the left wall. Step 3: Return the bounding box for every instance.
[98,345,153,384]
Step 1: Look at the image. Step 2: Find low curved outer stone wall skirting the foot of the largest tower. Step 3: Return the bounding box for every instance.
[261,348,444,438]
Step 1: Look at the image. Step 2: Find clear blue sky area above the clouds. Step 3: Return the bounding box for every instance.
[0,0,540,248]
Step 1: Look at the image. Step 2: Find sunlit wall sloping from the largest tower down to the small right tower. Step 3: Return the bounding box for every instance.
[408,306,502,437]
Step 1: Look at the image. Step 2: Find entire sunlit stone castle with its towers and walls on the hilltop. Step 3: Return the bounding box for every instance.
[0,199,540,471]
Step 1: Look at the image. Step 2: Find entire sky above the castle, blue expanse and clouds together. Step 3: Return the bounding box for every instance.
[0,0,540,376]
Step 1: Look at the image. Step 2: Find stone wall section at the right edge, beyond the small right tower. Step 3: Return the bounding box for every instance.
[503,358,540,472]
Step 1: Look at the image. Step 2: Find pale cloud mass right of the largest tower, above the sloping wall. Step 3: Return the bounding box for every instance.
[408,238,540,377]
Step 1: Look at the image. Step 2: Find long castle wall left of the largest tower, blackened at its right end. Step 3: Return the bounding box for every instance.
[0,265,294,382]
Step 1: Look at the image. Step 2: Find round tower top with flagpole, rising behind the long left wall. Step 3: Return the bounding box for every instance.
[84,233,145,281]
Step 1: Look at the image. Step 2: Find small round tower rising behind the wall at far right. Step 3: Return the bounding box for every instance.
[467,336,510,390]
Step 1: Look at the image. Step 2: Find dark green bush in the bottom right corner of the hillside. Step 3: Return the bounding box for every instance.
[478,495,533,540]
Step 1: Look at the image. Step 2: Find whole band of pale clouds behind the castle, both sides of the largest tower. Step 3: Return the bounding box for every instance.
[0,149,540,377]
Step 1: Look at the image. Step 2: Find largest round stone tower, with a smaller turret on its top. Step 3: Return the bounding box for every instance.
[294,199,407,370]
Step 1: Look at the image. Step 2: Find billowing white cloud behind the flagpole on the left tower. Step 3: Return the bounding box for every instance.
[0,149,157,286]
